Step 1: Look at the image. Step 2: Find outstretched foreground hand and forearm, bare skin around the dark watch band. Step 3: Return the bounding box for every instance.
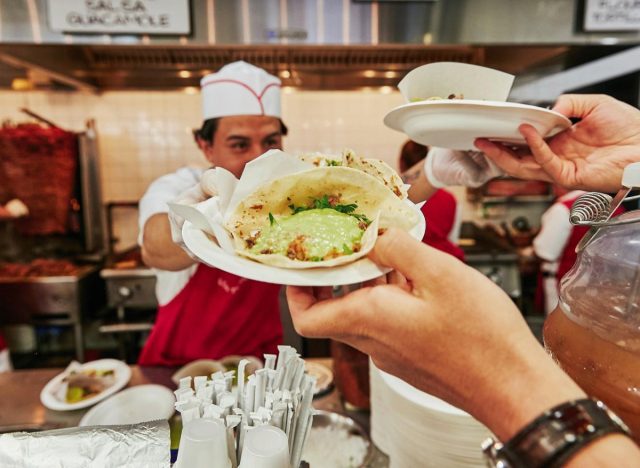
[287,229,640,466]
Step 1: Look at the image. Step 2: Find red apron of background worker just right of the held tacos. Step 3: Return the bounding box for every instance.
[421,189,464,261]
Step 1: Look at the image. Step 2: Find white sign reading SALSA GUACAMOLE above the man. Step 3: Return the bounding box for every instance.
[47,0,191,34]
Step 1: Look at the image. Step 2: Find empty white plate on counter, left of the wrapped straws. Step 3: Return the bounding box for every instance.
[79,385,176,426]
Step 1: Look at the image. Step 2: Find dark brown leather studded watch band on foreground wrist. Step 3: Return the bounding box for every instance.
[482,398,629,468]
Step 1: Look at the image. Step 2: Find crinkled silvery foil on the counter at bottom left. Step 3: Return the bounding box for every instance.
[0,421,170,468]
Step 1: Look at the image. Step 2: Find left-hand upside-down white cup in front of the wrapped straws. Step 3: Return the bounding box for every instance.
[175,419,231,468]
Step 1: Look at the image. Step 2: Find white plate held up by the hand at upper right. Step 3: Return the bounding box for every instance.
[384,99,571,150]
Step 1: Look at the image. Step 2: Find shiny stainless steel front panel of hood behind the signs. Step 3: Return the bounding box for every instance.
[5,0,640,46]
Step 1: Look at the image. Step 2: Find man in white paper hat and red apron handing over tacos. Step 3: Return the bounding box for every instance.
[139,62,287,366]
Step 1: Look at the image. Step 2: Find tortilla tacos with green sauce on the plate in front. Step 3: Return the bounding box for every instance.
[226,151,418,268]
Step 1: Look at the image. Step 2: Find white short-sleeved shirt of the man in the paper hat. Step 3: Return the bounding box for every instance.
[138,167,204,305]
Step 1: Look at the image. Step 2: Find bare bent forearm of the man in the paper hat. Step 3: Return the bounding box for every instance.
[142,213,195,271]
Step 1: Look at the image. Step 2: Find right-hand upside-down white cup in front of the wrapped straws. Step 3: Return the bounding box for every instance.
[238,425,289,468]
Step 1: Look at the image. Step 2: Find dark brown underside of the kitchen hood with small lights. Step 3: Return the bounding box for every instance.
[0,44,568,93]
